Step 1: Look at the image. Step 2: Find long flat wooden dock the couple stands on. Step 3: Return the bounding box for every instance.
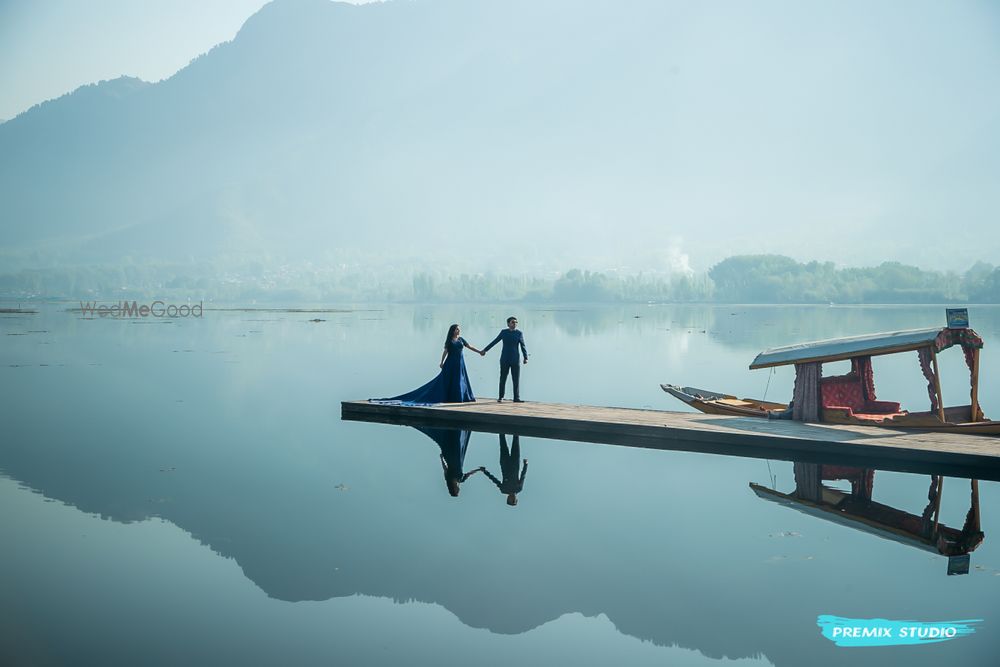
[341,399,1000,480]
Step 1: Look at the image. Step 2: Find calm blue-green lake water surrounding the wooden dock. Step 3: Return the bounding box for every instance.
[0,303,1000,666]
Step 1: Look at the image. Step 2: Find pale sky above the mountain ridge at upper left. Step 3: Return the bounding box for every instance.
[0,0,364,120]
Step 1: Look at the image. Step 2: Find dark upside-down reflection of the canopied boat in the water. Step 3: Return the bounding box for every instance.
[750,463,984,574]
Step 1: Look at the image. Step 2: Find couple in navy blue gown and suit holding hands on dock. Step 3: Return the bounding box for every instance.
[378,317,528,404]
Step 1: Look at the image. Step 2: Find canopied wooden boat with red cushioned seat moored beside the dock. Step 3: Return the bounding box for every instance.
[660,328,1000,435]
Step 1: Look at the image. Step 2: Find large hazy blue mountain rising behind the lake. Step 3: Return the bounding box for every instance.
[0,0,1000,269]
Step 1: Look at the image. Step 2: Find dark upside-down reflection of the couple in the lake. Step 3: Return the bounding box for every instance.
[417,427,528,507]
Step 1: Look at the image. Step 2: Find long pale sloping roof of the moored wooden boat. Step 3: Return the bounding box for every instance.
[750,328,983,370]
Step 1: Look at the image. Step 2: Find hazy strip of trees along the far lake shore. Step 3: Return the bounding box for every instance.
[0,255,1000,304]
